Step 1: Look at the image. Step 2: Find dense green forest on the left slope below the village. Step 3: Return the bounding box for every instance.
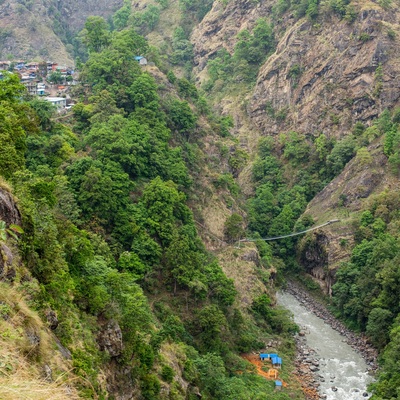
[0,18,296,400]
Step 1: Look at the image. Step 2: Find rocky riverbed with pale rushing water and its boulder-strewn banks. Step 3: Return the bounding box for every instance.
[279,283,377,400]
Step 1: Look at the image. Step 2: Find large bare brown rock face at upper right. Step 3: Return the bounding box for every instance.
[250,3,400,137]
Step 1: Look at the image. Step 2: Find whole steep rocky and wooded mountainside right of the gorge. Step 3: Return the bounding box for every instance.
[192,0,400,400]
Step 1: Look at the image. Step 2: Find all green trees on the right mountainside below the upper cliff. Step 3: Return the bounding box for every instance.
[247,110,400,399]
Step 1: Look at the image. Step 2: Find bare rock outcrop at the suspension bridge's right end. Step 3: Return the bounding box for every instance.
[299,143,398,293]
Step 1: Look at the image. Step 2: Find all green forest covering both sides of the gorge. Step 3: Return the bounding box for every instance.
[0,0,400,400]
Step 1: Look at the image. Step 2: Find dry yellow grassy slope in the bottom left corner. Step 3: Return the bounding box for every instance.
[0,282,80,400]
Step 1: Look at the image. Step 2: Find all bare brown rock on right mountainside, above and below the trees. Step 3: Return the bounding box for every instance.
[192,0,400,292]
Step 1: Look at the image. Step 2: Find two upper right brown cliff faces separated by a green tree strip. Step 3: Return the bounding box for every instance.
[192,0,400,137]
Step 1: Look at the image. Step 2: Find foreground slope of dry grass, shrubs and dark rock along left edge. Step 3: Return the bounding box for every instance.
[0,187,80,400]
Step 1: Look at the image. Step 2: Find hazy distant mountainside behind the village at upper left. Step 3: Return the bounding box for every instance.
[0,0,123,66]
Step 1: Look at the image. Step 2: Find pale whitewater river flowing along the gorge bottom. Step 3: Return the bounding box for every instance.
[277,292,373,400]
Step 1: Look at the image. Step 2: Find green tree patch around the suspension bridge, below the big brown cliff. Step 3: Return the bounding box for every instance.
[248,117,372,266]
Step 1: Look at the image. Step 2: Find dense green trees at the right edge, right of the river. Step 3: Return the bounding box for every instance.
[320,110,400,400]
